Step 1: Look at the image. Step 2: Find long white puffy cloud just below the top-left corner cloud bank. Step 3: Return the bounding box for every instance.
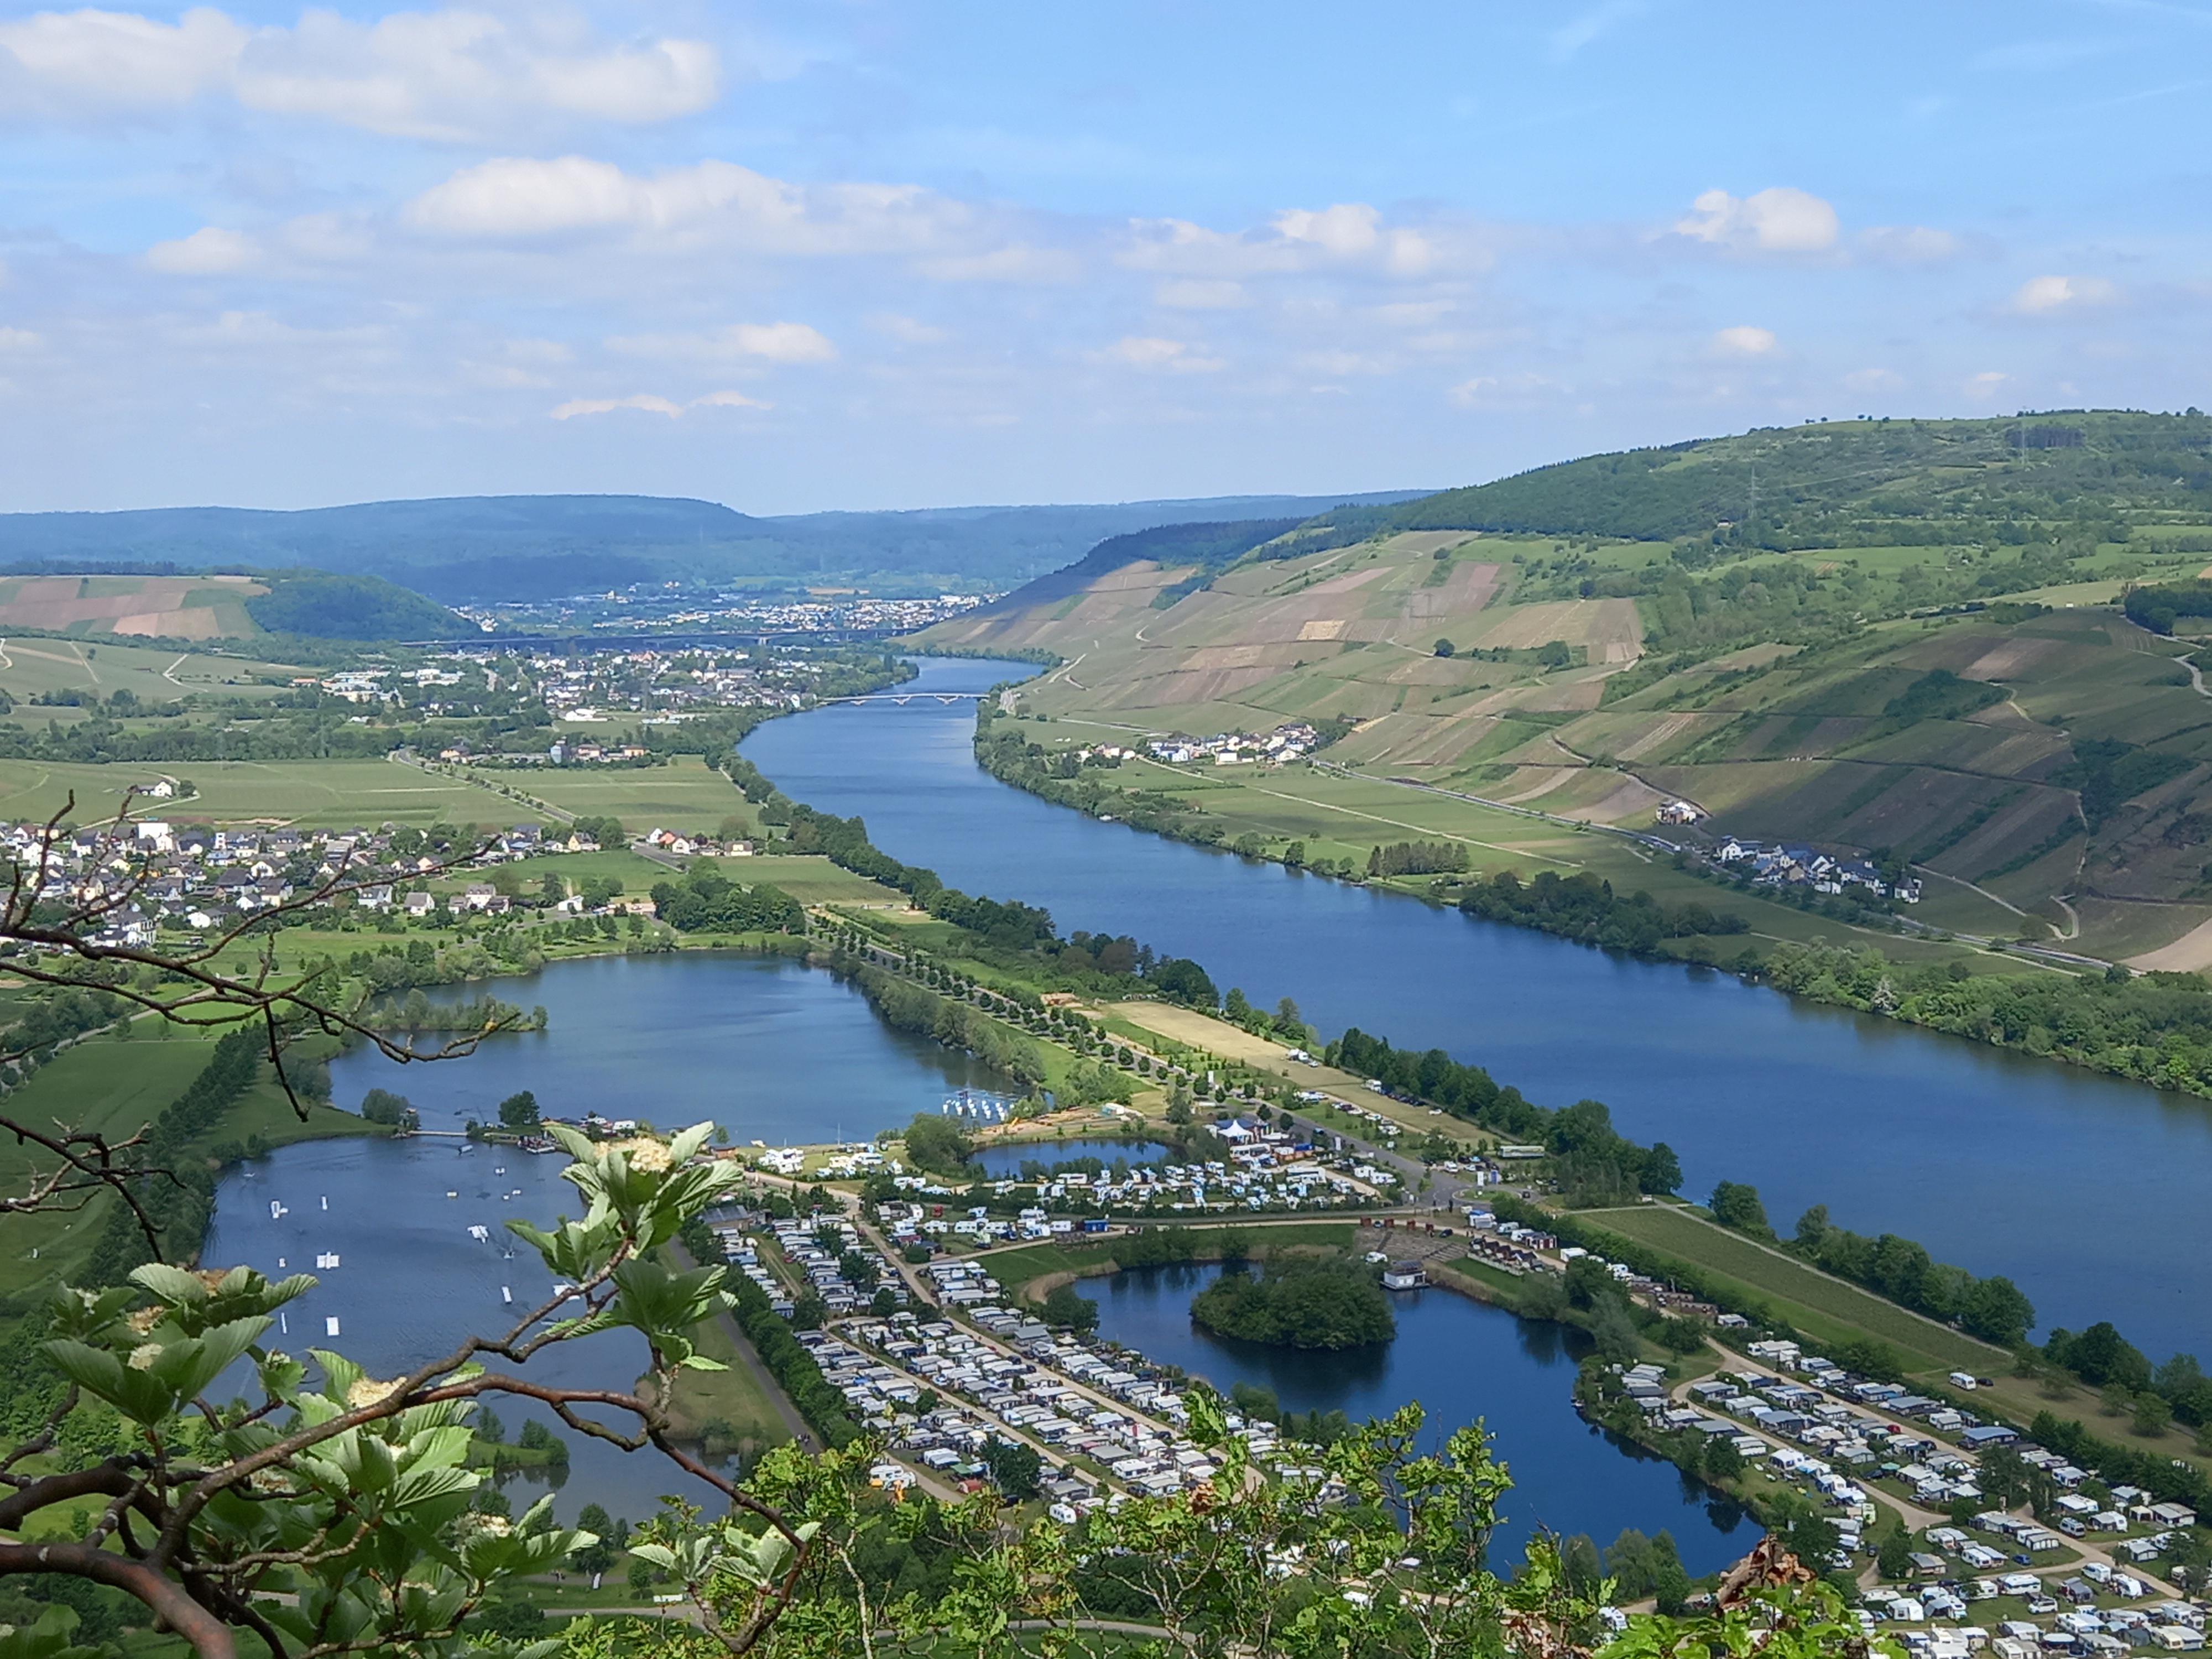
[403,155,969,254]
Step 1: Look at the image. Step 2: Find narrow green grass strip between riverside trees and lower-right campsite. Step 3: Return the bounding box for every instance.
[1577,1206,2011,1374]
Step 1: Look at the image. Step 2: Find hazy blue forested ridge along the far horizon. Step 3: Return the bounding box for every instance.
[0,491,1418,604]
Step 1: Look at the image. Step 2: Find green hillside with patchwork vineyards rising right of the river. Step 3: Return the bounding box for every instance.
[925,414,2212,969]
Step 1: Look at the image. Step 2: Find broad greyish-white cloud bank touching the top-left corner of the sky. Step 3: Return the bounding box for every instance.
[0,7,721,139]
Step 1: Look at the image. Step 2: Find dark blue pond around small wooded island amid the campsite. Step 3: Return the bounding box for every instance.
[1077,1265,1759,1575]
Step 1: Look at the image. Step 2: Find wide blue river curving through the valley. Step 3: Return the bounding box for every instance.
[743,659,2212,1358]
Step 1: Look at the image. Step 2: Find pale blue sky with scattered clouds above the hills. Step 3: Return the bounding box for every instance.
[0,0,2212,513]
